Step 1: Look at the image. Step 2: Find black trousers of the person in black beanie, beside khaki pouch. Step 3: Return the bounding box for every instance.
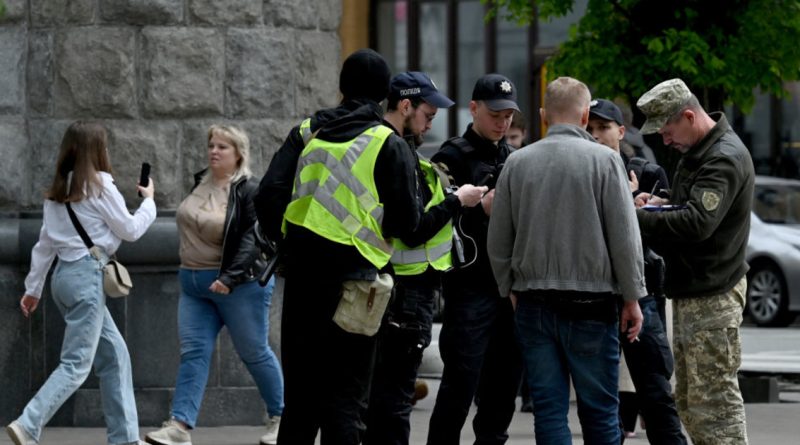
[278,274,376,445]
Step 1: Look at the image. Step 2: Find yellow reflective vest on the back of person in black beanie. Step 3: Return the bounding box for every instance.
[283,119,393,269]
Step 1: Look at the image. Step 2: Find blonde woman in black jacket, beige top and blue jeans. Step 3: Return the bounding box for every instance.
[146,125,283,445]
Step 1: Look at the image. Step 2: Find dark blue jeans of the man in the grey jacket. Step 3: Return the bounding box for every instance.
[514,296,621,445]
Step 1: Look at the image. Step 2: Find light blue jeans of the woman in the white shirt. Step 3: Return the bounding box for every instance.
[18,255,139,444]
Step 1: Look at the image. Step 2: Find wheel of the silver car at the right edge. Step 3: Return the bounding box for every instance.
[747,263,795,326]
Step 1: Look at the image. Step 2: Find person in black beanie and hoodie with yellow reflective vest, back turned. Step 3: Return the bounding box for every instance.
[255,50,422,445]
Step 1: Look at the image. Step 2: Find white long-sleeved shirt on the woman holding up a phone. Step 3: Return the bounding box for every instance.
[25,172,156,297]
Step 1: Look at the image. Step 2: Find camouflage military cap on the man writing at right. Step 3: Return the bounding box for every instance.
[636,79,692,134]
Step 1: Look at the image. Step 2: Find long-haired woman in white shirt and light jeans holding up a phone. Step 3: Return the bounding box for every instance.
[6,121,156,445]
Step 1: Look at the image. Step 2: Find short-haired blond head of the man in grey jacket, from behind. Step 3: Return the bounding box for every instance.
[544,77,592,124]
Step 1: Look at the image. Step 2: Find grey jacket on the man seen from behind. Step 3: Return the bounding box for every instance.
[488,124,647,301]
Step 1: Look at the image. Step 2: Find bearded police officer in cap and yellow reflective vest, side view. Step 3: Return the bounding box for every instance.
[364,71,488,445]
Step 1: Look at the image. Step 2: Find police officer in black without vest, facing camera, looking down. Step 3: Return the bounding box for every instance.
[428,74,522,445]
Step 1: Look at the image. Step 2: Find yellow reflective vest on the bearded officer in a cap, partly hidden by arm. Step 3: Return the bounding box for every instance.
[391,159,453,275]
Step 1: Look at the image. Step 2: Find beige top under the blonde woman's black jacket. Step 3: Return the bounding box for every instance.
[175,180,230,269]
